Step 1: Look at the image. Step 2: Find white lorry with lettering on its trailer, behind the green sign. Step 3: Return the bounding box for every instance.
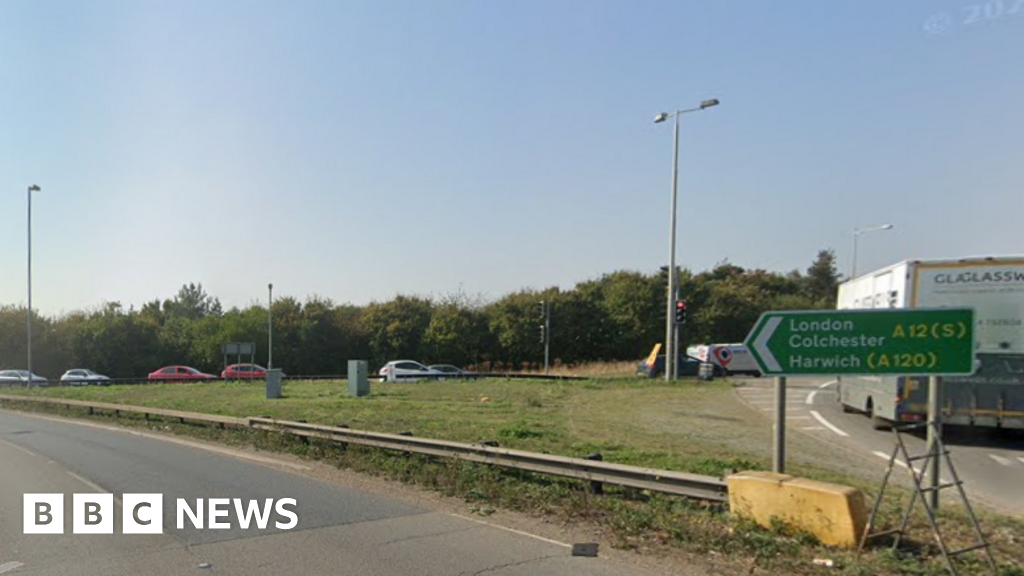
[837,256,1024,428]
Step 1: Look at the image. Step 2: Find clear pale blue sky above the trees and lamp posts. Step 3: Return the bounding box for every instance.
[0,0,1024,314]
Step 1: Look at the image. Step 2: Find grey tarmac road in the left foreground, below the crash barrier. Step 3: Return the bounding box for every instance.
[0,411,667,576]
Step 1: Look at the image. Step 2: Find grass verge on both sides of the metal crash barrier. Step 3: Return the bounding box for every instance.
[3,380,1024,576]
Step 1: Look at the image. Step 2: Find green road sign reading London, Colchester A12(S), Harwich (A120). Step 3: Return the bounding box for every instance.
[745,308,975,376]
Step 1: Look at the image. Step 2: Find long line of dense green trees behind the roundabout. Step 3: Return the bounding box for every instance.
[0,250,840,378]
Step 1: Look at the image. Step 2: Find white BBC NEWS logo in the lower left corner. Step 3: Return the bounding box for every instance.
[24,493,299,534]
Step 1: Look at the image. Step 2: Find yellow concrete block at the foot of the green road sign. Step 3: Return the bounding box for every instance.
[725,471,867,547]
